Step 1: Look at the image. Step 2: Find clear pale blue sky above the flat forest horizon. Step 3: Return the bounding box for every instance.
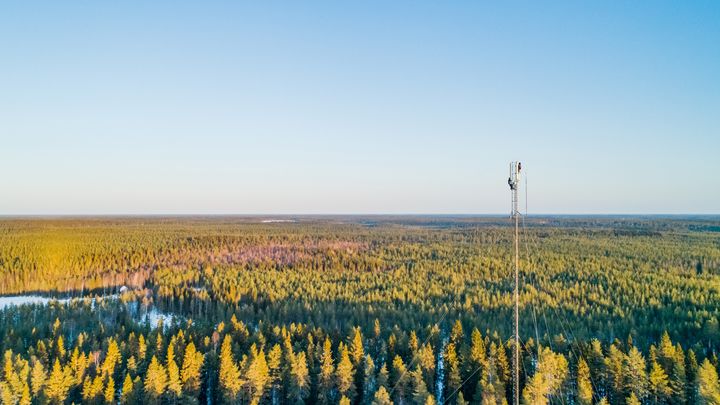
[0,0,720,215]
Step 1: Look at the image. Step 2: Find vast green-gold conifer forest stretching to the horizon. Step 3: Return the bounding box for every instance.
[0,216,720,405]
